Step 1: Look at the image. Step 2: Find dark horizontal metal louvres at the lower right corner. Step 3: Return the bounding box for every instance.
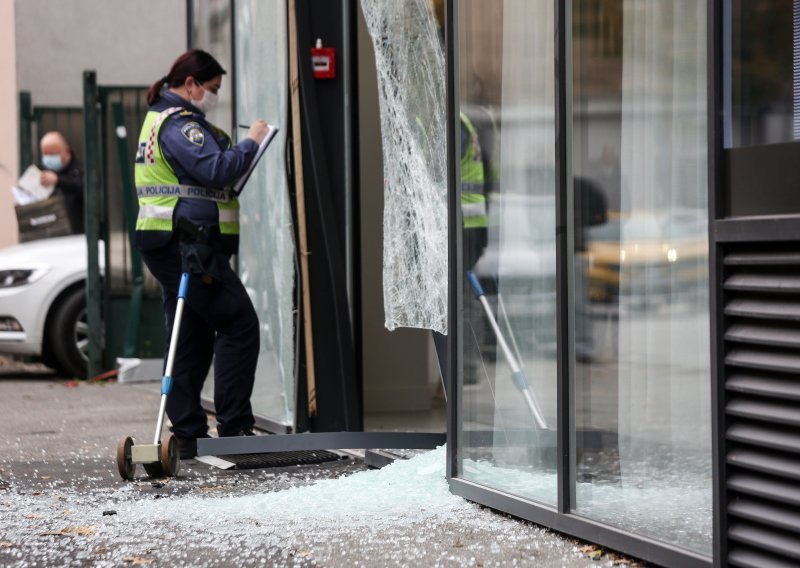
[722,242,800,567]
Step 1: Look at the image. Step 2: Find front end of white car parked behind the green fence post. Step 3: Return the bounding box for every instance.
[0,235,97,377]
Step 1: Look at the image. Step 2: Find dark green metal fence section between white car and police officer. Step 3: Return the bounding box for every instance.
[83,71,165,377]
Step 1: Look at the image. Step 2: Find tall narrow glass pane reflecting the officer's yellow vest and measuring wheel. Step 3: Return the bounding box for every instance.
[458,0,557,505]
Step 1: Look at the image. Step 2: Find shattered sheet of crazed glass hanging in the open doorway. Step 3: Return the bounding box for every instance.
[361,0,447,333]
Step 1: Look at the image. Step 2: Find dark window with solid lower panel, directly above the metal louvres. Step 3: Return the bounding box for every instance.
[722,0,800,216]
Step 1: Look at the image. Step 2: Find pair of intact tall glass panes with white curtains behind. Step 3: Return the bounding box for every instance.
[454,0,712,555]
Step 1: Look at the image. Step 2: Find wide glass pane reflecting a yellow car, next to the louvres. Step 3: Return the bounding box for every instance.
[570,0,712,554]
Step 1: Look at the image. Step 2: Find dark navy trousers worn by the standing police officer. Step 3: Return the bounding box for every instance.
[141,234,261,438]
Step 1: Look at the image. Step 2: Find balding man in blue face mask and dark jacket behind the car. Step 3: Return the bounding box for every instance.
[39,130,85,234]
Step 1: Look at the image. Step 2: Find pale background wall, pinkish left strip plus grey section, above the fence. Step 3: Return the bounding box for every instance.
[0,0,187,247]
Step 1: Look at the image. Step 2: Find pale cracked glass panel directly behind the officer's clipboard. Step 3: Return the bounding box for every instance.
[235,0,295,426]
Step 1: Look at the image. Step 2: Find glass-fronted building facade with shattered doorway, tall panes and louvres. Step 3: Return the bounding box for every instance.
[192,0,800,566]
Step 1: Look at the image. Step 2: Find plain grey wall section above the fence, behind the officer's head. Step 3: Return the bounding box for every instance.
[14,0,186,105]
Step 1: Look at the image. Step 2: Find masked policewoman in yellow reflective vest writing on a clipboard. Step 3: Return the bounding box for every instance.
[135,49,268,459]
